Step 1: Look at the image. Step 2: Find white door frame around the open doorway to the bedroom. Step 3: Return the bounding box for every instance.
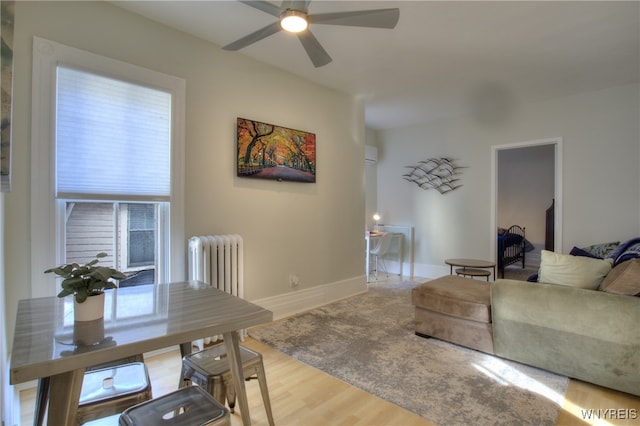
[489,137,563,262]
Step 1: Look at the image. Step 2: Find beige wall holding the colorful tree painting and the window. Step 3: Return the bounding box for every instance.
[4,2,365,342]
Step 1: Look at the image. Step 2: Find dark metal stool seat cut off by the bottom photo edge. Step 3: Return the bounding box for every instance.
[119,386,231,426]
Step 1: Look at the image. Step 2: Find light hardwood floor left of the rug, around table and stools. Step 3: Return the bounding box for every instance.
[20,338,431,426]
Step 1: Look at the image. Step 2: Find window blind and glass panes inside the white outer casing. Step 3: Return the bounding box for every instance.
[55,66,171,285]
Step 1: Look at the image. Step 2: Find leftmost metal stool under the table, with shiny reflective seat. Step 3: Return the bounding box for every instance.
[78,362,153,424]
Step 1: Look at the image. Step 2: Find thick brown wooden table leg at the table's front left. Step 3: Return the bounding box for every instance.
[47,368,84,426]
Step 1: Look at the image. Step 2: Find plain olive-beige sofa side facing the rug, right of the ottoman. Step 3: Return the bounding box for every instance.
[491,280,640,395]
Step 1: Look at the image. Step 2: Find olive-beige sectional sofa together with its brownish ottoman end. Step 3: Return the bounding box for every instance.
[412,253,640,396]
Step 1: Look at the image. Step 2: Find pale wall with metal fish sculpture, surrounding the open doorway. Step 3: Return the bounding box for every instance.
[377,85,640,276]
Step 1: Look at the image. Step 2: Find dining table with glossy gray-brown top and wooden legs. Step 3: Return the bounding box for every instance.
[10,281,273,426]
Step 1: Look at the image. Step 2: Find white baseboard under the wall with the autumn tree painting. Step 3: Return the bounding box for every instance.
[251,275,367,320]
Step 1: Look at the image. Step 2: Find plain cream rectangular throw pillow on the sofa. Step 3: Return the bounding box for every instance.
[538,250,613,290]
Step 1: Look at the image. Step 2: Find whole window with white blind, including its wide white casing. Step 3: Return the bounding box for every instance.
[30,36,186,295]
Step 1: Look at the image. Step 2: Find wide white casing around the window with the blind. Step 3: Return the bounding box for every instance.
[30,37,186,297]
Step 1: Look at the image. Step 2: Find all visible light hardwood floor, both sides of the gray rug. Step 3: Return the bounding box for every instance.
[20,278,640,426]
